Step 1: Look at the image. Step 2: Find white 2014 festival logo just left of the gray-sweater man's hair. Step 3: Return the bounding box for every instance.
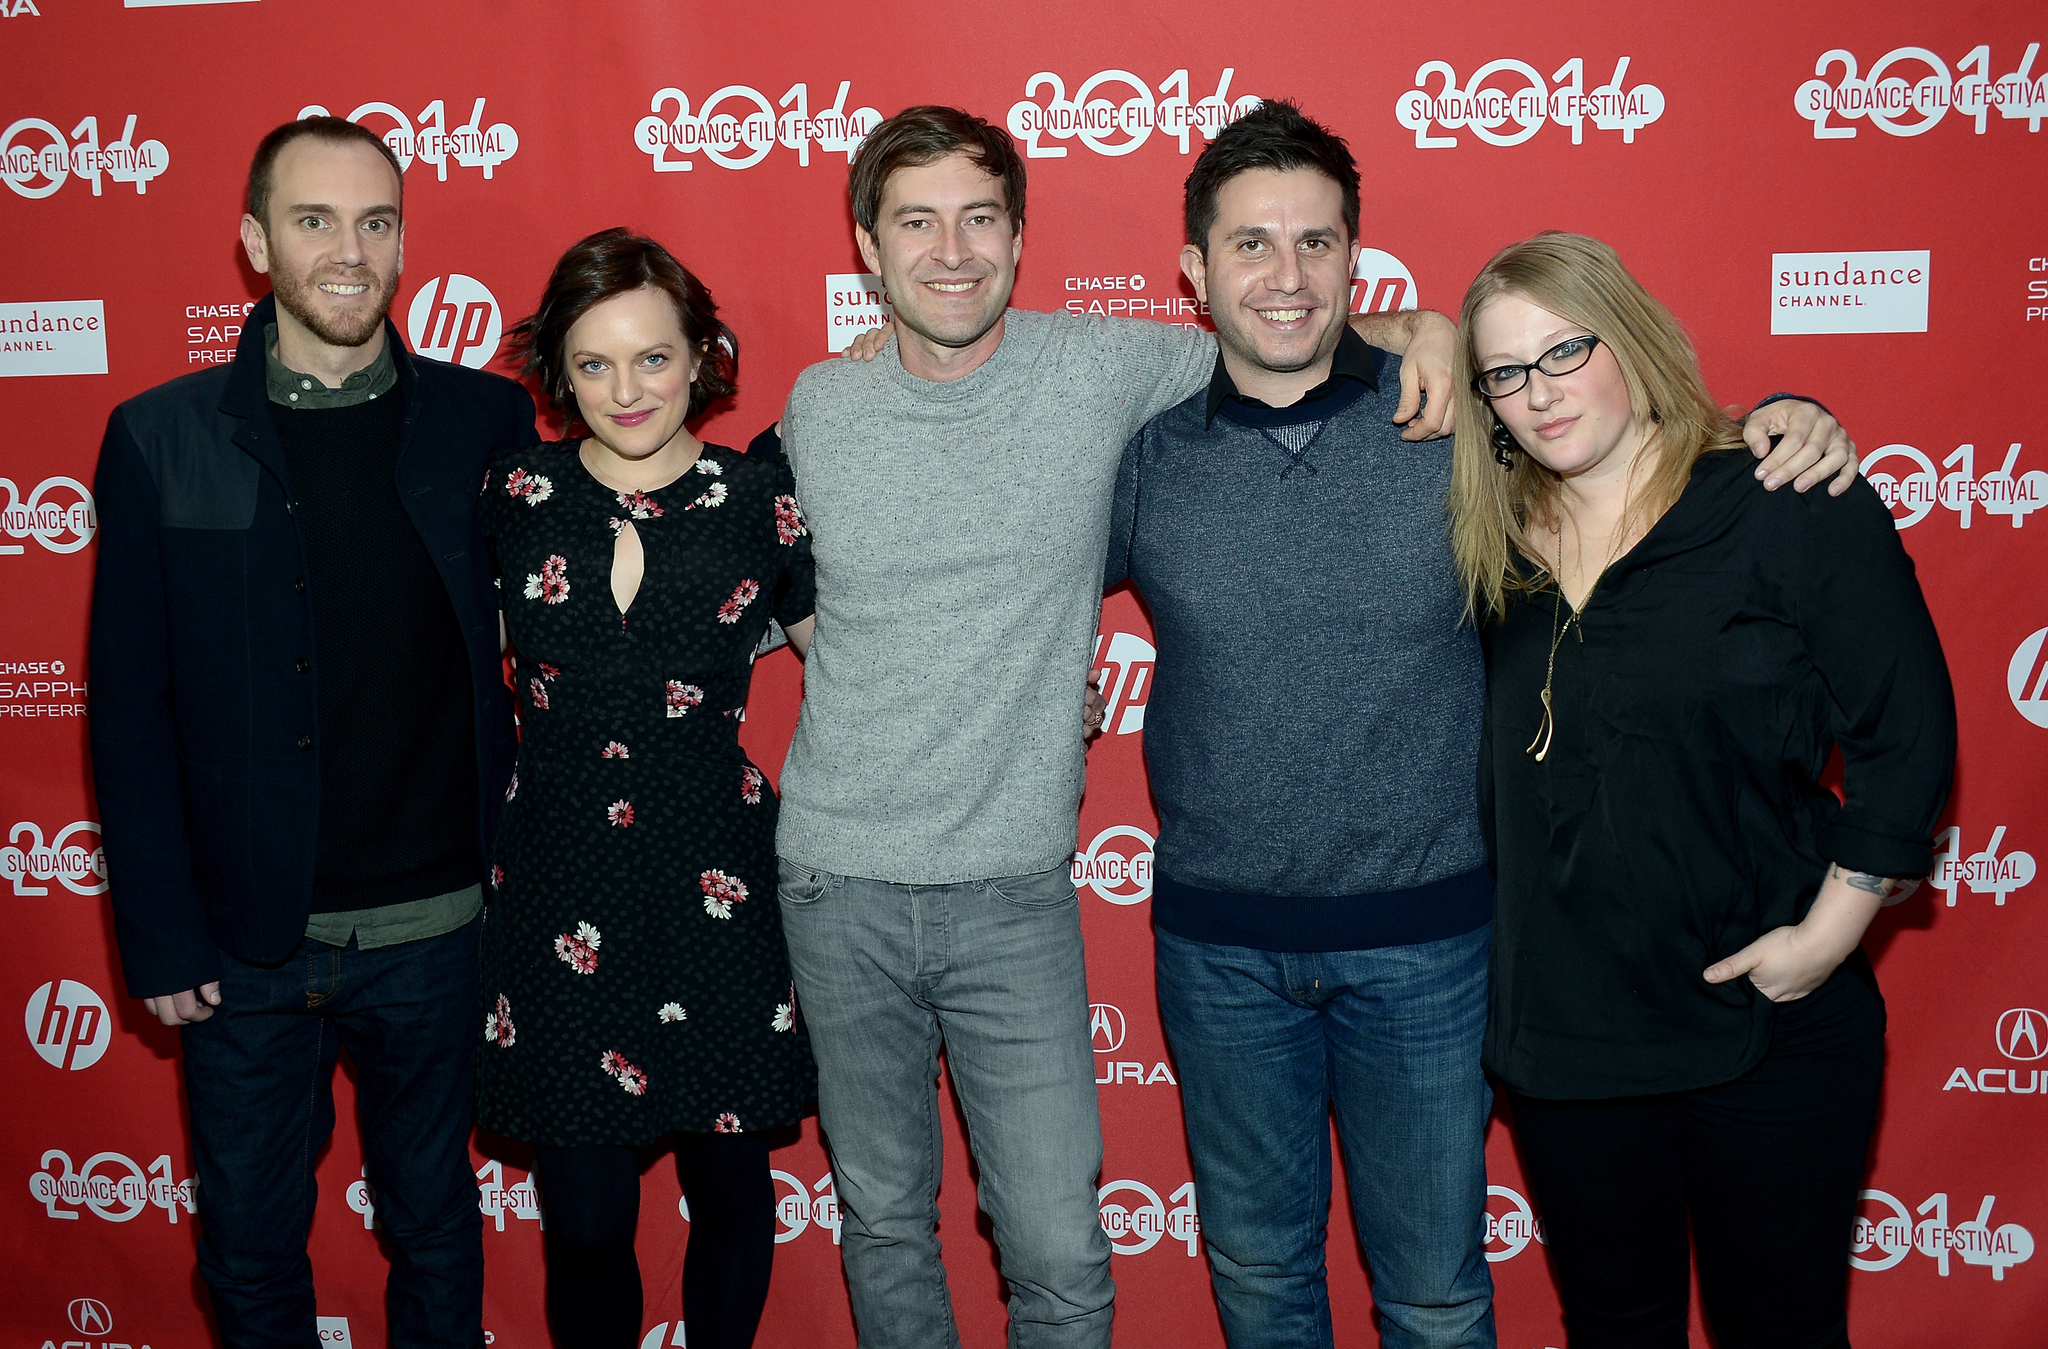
[633,80,883,174]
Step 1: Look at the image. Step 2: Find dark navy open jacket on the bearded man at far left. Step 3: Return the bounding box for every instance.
[88,297,539,997]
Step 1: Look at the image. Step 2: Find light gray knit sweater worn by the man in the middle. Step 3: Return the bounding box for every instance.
[776,309,1217,884]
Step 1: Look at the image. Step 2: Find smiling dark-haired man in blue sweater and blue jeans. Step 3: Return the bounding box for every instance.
[1104,102,1853,1349]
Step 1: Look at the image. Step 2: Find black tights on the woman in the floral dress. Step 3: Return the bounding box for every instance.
[535,1134,774,1349]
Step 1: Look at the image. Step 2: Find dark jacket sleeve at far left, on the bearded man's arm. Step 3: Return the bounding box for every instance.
[86,407,221,997]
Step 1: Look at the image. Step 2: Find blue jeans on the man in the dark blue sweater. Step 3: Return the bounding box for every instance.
[1155,925,1493,1349]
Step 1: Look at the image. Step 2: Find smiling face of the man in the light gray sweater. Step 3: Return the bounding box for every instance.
[858,154,1024,358]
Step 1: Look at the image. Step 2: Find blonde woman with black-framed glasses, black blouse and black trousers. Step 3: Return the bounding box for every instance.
[1450,233,1956,1349]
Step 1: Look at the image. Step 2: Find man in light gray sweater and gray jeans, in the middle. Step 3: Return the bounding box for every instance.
[776,108,1450,1349]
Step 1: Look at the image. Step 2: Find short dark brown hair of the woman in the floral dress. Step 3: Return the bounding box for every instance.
[510,225,739,422]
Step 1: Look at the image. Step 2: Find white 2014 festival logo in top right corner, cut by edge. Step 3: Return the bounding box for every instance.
[1792,43,2048,141]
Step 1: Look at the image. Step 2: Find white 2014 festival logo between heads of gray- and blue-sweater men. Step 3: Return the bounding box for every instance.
[1008,66,1262,160]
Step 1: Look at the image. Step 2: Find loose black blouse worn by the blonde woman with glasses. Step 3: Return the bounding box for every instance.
[1479,450,1956,1099]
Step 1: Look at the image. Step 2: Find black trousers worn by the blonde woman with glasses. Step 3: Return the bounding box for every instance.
[1509,956,1884,1349]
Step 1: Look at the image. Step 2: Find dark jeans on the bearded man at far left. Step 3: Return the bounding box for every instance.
[184,921,483,1349]
